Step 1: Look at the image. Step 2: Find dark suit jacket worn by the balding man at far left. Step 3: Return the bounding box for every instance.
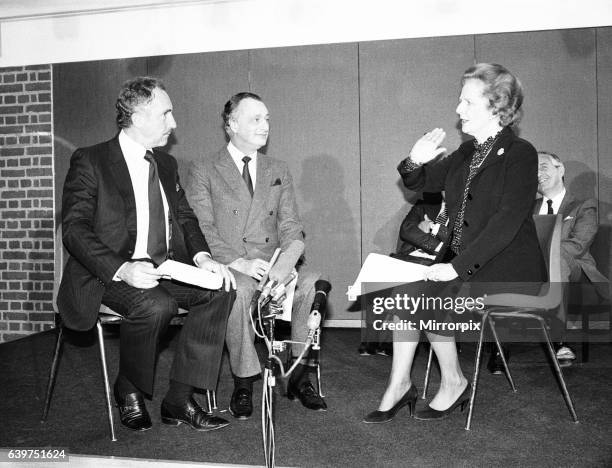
[57,137,210,330]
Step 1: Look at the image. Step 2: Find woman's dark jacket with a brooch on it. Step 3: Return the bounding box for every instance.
[398,127,547,282]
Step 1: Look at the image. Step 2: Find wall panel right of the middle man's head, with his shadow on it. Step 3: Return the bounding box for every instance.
[251,44,361,319]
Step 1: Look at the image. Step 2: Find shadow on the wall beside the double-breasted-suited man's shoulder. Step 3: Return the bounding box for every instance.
[297,154,361,315]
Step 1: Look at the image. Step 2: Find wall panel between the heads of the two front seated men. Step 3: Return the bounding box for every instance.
[147,51,248,181]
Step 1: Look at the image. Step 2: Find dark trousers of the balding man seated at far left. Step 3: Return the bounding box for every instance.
[102,280,235,395]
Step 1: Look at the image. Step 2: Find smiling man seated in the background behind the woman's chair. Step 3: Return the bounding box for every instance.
[533,151,609,364]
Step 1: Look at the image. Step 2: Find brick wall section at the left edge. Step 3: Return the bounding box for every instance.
[0,65,54,342]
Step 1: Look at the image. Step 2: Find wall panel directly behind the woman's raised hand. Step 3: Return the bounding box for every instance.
[359,36,474,258]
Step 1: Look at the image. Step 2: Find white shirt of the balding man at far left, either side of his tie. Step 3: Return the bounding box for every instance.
[119,130,169,258]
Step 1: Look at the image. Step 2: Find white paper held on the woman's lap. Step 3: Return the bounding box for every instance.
[346,253,429,301]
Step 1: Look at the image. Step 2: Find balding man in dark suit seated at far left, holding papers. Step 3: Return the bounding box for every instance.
[57,77,235,431]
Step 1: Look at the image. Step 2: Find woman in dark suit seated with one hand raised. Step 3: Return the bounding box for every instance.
[364,63,546,423]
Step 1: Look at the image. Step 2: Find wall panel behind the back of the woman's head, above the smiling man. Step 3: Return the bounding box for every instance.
[476,29,597,198]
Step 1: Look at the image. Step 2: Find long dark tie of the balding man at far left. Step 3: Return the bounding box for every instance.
[145,151,167,265]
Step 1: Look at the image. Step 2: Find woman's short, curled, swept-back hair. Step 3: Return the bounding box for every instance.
[461,63,523,127]
